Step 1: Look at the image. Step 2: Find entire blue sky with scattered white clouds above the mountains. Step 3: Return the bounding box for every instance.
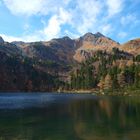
[0,0,140,43]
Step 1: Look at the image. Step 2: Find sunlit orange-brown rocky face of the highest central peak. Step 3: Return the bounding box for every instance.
[74,32,119,62]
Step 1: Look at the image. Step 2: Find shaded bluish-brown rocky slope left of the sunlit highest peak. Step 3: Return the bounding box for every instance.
[13,37,76,64]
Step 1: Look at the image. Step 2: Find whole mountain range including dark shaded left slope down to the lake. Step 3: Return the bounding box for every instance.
[0,32,140,91]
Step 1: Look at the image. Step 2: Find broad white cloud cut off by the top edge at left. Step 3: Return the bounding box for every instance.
[3,0,70,16]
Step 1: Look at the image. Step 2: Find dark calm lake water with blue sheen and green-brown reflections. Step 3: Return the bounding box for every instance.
[0,93,140,140]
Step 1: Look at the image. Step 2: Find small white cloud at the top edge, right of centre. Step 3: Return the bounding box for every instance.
[106,0,124,16]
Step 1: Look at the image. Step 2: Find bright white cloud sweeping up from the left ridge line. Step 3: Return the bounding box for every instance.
[1,8,71,42]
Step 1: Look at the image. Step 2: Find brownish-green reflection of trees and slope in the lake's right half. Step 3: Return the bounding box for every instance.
[69,97,140,140]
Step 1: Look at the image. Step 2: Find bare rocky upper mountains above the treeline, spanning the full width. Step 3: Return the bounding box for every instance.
[0,32,140,64]
